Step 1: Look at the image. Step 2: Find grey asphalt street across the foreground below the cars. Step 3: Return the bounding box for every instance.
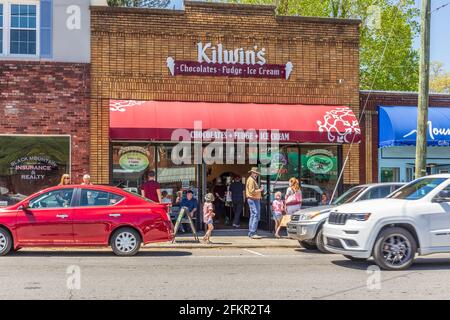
[0,248,450,300]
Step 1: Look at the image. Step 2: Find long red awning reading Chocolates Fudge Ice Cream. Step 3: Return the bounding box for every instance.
[110,100,361,143]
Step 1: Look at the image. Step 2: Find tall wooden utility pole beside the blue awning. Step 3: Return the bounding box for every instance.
[416,0,431,178]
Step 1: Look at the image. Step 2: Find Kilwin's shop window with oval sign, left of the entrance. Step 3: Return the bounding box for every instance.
[112,144,155,193]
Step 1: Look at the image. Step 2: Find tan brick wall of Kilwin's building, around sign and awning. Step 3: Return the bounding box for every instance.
[91,2,360,184]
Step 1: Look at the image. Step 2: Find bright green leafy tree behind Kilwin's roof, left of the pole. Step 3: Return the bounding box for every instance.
[222,0,420,91]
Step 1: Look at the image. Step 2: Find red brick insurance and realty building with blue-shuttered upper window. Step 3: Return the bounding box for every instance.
[0,0,90,206]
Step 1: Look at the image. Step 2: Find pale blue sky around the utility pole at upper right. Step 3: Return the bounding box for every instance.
[414,0,450,71]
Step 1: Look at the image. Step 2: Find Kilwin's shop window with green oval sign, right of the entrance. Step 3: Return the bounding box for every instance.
[300,146,339,206]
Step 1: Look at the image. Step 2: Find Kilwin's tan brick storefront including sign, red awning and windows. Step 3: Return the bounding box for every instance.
[91,2,361,227]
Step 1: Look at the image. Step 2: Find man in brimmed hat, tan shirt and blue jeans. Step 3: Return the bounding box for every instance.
[245,167,264,239]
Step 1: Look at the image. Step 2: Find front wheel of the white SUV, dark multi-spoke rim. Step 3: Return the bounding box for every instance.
[373,228,417,270]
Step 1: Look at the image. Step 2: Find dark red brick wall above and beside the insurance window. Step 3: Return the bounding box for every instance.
[0,61,90,179]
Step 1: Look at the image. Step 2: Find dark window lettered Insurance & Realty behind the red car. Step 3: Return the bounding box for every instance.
[0,135,70,206]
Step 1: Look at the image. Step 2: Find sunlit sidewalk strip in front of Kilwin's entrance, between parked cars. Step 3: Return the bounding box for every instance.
[145,230,299,249]
